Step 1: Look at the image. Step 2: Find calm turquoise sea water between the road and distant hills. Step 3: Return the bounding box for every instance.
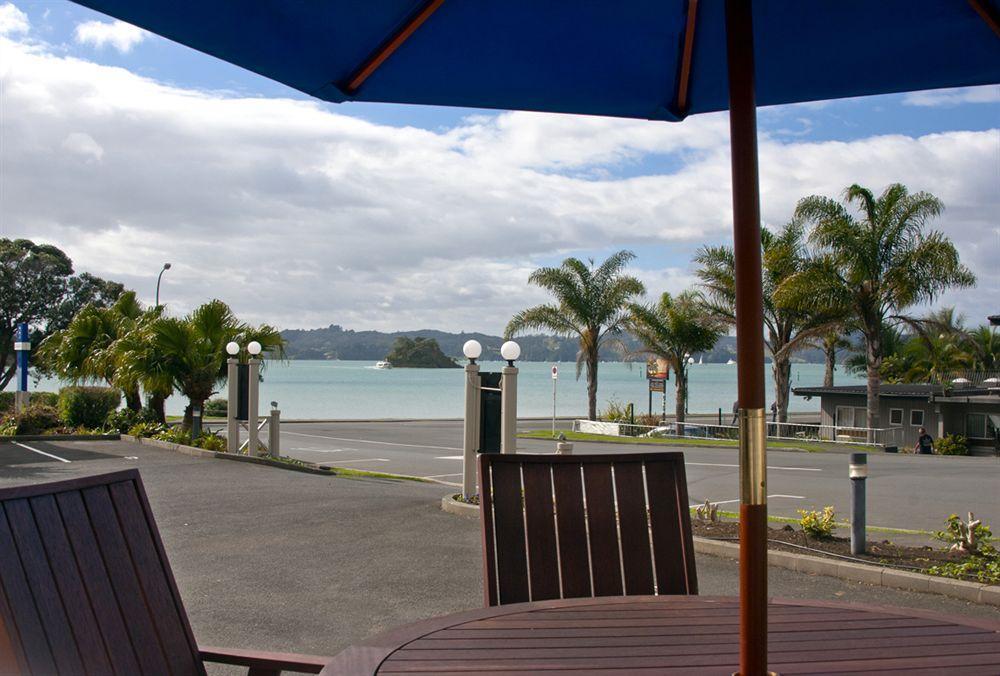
[15,360,864,419]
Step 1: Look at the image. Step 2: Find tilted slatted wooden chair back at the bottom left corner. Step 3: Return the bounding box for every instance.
[0,470,205,676]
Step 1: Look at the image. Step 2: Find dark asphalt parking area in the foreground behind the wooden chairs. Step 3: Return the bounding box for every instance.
[0,434,996,655]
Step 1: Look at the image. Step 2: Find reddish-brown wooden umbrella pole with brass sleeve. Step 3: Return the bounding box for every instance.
[726,0,767,676]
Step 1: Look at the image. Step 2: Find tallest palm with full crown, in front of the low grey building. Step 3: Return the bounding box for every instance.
[785,183,976,434]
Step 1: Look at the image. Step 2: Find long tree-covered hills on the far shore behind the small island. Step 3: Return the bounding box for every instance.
[281,324,823,363]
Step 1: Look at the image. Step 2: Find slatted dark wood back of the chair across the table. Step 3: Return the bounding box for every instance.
[479,453,698,606]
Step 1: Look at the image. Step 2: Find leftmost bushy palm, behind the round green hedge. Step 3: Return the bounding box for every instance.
[38,291,143,411]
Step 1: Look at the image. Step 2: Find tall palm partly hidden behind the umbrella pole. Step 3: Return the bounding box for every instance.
[695,221,842,422]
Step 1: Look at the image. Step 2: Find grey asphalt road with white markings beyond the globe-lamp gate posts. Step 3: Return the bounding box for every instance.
[236,420,1000,541]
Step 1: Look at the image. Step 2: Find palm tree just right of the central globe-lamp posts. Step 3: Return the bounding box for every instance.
[504,251,645,420]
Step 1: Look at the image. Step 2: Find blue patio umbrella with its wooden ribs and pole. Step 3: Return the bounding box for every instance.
[66,0,1000,676]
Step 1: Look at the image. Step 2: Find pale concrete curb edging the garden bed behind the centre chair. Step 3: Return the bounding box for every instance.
[441,495,1000,606]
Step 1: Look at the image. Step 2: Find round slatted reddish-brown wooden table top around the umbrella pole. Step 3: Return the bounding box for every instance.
[322,596,1000,676]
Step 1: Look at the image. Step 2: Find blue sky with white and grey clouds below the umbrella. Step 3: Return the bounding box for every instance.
[0,0,1000,332]
